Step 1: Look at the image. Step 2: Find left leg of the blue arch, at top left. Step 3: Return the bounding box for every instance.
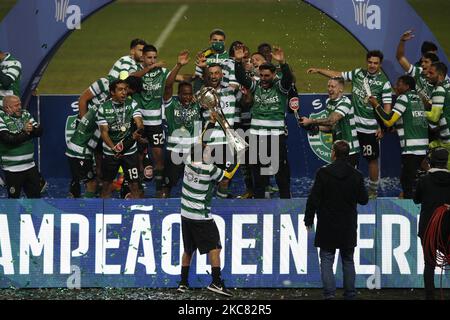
[0,0,112,104]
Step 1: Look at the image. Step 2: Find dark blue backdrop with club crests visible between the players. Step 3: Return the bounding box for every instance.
[29,94,400,179]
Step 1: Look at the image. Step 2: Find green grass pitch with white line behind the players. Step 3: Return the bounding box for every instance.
[0,0,450,299]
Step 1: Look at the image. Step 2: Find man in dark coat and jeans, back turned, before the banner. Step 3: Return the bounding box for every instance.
[304,140,369,299]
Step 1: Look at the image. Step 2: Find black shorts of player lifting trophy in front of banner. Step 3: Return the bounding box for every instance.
[181,216,222,255]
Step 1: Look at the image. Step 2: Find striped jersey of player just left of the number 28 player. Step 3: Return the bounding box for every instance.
[326,96,359,154]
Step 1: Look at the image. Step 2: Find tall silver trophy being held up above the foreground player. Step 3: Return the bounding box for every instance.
[195,87,248,153]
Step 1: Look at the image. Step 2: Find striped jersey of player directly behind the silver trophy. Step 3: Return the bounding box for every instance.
[203,86,237,145]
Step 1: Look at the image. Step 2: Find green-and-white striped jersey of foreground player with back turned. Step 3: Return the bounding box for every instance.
[181,157,224,220]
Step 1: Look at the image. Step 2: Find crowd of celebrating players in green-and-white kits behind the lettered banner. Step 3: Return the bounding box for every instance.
[0,29,450,201]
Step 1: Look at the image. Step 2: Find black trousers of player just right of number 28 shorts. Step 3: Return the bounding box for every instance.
[400,154,425,199]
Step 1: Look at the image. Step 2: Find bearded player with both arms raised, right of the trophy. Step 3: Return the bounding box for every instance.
[235,46,293,199]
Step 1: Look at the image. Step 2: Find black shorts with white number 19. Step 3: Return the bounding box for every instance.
[102,152,139,182]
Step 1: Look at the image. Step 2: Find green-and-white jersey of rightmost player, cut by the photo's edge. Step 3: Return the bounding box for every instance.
[430,80,450,143]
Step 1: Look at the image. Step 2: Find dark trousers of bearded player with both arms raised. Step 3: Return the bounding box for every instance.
[250,135,291,199]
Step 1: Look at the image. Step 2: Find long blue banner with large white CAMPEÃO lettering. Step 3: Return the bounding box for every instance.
[0,199,450,289]
